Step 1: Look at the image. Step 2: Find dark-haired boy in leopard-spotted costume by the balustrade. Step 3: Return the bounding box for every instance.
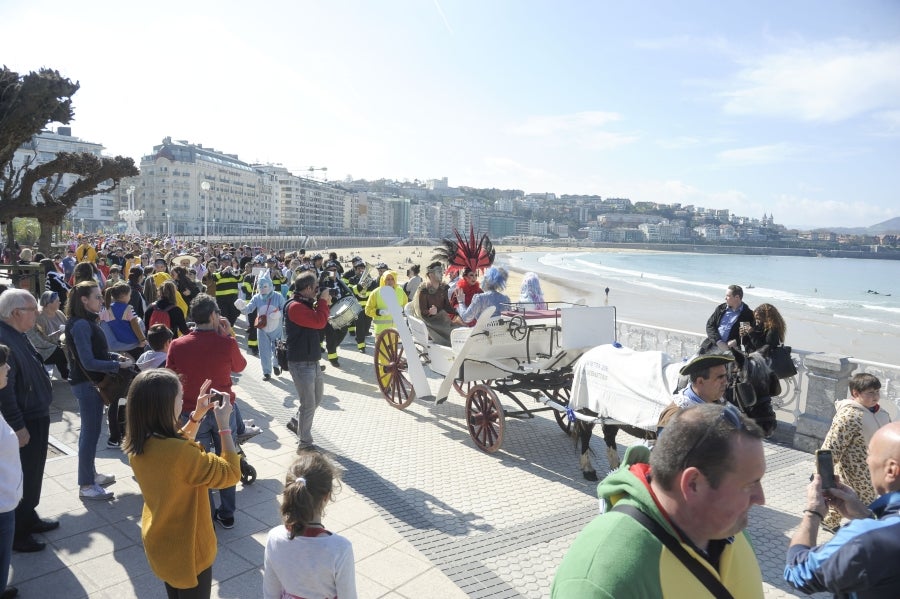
[822,373,891,530]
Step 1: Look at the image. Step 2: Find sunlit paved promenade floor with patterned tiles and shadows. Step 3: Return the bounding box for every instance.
[10,321,814,599]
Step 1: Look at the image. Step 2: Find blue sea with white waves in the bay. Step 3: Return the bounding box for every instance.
[500,252,900,334]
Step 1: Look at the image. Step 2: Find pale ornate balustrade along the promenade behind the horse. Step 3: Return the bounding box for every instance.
[616,321,900,452]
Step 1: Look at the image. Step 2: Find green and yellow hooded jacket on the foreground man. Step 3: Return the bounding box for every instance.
[551,454,763,599]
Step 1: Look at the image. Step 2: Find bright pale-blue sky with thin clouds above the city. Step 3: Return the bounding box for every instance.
[0,0,900,229]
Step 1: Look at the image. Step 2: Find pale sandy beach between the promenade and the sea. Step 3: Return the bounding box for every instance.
[330,245,900,364]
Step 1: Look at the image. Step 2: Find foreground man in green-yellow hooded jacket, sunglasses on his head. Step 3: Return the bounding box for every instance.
[551,404,766,599]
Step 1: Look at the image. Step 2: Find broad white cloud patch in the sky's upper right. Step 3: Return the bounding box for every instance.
[722,39,900,122]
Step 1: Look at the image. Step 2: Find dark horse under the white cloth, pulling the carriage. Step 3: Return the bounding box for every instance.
[570,350,781,481]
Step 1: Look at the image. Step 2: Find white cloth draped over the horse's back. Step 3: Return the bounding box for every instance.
[569,345,681,431]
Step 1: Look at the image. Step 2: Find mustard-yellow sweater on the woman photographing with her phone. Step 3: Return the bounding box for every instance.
[130,437,241,589]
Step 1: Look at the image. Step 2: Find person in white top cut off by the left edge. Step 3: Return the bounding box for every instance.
[0,345,23,599]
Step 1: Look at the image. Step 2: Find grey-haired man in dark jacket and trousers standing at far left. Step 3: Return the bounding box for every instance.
[0,289,59,553]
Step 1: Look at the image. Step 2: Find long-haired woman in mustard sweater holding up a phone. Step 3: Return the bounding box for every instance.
[124,368,241,597]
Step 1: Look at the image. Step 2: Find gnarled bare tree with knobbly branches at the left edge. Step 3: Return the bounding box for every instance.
[0,66,140,253]
